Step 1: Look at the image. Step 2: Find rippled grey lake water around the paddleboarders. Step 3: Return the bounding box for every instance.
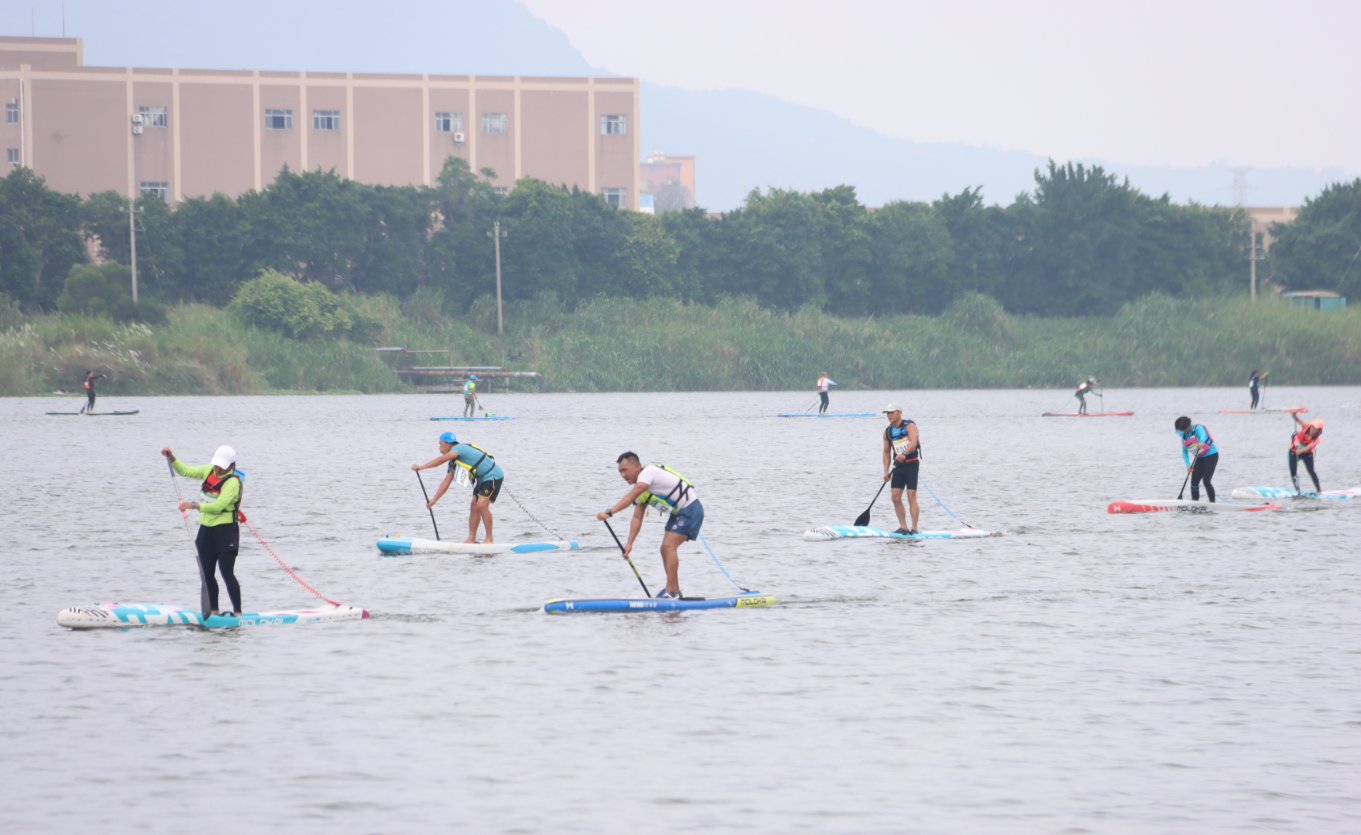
[0,388,1361,834]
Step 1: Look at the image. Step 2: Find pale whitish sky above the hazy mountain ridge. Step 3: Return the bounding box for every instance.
[524,0,1361,173]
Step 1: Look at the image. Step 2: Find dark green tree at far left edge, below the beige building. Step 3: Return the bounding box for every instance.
[0,169,86,310]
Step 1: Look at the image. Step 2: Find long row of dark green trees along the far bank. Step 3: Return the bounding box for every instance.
[0,158,1361,316]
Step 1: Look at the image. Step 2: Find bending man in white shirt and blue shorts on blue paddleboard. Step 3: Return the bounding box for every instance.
[596,453,704,598]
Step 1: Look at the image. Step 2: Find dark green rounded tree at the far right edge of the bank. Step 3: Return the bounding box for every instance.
[1271,178,1361,298]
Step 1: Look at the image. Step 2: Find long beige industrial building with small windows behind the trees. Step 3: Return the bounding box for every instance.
[0,37,641,209]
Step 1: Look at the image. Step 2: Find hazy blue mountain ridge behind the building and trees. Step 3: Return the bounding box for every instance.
[34,0,1343,211]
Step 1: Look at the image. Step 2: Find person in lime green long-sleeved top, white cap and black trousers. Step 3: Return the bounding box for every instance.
[161,446,242,615]
